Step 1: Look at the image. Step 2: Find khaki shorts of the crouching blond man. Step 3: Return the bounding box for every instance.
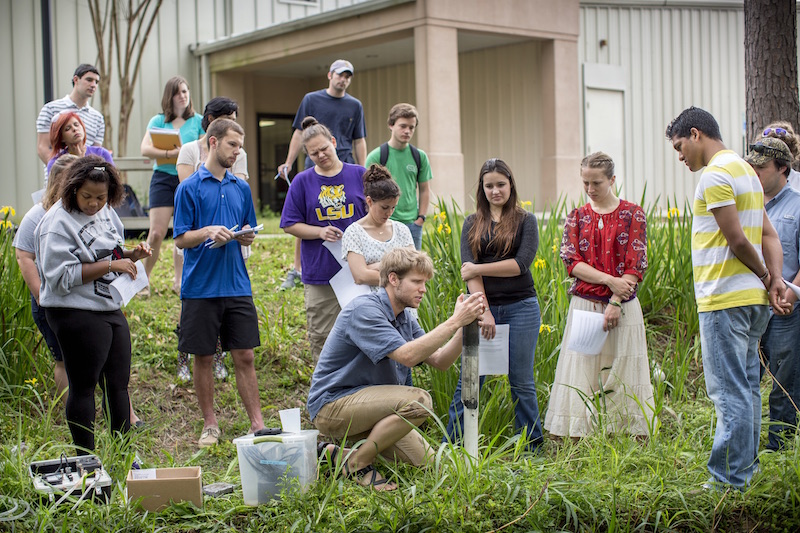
[314,385,434,466]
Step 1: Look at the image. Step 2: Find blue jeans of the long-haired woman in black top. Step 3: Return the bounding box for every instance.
[442,296,543,450]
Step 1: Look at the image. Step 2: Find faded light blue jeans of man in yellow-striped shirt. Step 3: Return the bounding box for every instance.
[699,305,769,488]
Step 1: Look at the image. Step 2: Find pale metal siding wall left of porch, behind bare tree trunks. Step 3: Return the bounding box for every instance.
[0,0,367,212]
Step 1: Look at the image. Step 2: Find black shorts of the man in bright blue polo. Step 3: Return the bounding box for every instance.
[178,296,261,355]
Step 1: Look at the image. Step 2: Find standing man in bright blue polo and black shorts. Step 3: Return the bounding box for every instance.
[174,119,264,447]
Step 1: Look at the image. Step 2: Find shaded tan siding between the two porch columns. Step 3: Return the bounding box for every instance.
[456,41,544,209]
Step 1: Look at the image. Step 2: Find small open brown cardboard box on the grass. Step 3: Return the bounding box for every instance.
[126,466,203,512]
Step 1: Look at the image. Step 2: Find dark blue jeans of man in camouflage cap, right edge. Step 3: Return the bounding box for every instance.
[761,305,800,451]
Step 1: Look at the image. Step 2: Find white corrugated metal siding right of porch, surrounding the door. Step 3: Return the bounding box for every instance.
[579,6,745,207]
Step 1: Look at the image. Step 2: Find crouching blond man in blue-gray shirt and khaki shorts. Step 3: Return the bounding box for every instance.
[308,248,485,490]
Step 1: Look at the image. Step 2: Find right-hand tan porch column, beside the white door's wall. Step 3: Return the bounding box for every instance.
[536,40,583,203]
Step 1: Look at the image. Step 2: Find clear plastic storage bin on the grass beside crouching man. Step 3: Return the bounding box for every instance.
[233,429,319,505]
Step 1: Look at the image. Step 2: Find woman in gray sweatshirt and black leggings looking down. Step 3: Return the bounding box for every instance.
[35,156,150,454]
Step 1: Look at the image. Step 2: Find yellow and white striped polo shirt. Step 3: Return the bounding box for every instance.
[692,150,768,313]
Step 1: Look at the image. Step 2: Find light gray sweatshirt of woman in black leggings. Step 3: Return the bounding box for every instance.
[36,200,124,311]
